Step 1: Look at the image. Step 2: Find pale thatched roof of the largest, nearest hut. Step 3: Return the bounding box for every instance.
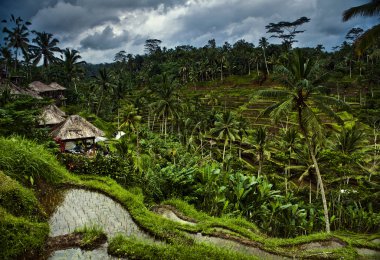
[51,115,104,140]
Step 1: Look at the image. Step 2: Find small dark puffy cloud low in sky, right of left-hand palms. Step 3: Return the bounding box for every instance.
[80,26,128,50]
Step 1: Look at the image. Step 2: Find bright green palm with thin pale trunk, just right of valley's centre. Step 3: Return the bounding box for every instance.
[210,111,239,161]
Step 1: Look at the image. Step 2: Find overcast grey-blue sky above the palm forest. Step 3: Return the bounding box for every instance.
[0,0,378,63]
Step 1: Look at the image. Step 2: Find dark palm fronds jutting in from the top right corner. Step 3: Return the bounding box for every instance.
[343,0,380,55]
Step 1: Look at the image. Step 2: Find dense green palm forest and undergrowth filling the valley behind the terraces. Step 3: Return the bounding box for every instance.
[0,5,380,258]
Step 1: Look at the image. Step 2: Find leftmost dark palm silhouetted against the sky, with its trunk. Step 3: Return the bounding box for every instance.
[3,15,31,69]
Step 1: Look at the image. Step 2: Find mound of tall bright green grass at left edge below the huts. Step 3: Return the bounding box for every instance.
[0,136,69,185]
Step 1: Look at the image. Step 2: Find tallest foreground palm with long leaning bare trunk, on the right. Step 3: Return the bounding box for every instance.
[258,50,348,233]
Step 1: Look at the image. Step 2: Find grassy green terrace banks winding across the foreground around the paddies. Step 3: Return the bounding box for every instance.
[0,137,380,259]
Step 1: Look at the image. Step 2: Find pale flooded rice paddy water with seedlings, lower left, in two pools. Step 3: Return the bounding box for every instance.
[46,189,153,259]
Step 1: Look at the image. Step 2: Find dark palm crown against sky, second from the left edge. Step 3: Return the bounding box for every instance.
[31,31,62,68]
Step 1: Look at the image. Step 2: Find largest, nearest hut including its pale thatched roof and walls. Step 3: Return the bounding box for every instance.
[51,115,104,152]
